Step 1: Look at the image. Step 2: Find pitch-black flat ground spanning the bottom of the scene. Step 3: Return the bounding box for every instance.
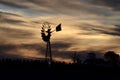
[0,60,120,80]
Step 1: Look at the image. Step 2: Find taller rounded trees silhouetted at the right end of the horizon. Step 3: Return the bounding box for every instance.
[70,51,120,65]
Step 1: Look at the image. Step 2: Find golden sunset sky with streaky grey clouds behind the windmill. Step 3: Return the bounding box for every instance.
[0,0,120,61]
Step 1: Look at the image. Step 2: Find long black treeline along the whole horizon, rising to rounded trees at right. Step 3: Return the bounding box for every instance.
[0,51,120,69]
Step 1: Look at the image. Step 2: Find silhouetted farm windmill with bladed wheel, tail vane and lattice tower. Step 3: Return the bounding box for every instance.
[41,22,62,63]
